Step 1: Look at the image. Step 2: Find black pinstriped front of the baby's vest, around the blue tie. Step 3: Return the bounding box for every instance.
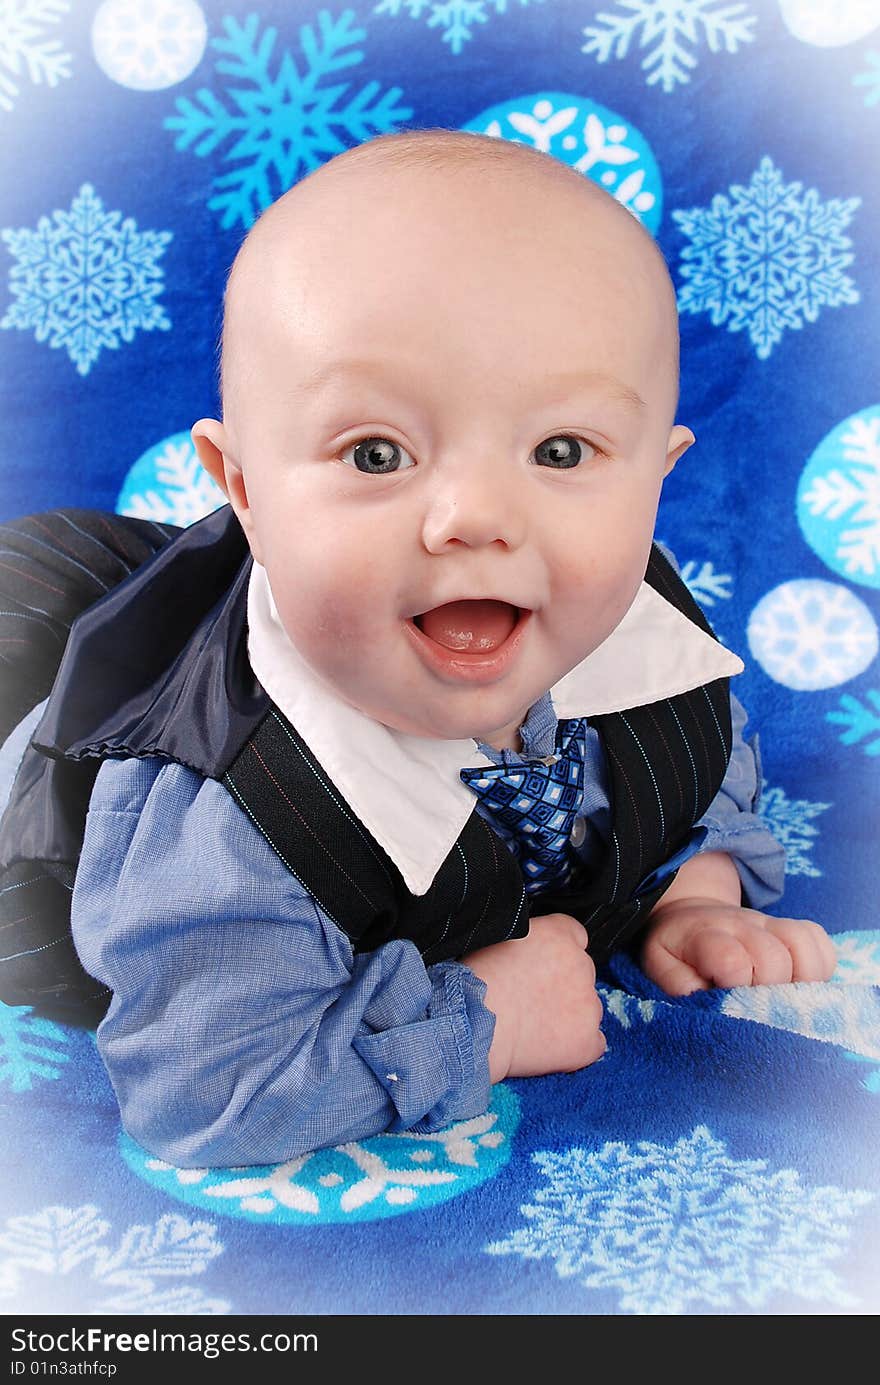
[222,546,732,964]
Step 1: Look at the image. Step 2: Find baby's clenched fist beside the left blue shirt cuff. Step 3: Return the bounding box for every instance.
[461,914,606,1082]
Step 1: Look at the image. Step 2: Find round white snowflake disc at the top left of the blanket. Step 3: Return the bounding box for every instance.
[91,0,208,91]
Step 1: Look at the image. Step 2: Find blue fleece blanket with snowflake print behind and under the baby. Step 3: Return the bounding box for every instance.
[0,0,880,1316]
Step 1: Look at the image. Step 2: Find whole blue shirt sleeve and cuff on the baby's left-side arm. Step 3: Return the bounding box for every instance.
[72,756,495,1168]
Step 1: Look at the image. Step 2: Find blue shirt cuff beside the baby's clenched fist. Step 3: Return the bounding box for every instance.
[352,963,495,1133]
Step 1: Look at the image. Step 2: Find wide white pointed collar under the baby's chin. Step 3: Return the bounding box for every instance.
[248,561,744,895]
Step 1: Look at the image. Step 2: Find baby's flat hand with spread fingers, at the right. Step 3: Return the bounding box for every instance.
[642,897,837,996]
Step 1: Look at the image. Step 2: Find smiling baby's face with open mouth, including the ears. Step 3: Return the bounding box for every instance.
[193,154,693,745]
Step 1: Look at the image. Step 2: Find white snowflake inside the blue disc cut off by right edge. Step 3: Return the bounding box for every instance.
[798,414,880,580]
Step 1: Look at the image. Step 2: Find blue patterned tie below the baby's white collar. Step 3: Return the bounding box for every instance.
[459,717,585,895]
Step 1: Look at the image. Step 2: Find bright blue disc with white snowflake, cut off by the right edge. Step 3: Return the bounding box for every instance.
[797,407,880,587]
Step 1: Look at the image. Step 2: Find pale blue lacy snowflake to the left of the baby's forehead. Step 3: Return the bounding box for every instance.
[0,183,172,375]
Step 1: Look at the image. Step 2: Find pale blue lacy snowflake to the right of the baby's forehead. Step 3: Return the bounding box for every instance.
[672,155,861,360]
